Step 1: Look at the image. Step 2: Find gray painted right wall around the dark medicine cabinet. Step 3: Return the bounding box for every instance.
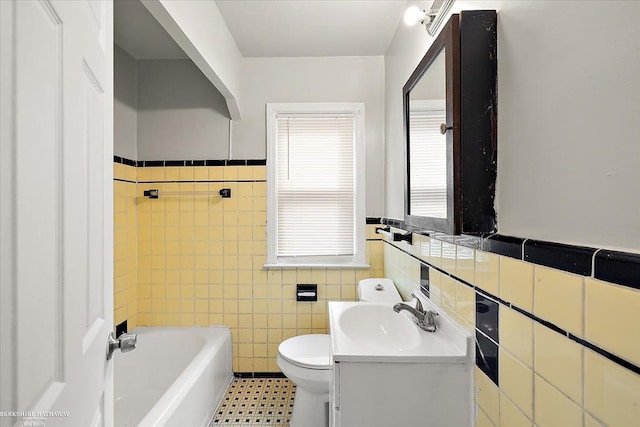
[385,0,640,252]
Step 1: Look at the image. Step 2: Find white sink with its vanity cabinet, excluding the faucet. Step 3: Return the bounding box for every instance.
[329,298,475,427]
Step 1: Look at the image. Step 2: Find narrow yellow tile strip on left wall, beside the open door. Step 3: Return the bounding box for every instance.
[113,163,138,329]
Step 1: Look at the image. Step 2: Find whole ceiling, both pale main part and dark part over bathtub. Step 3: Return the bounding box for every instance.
[114,0,407,59]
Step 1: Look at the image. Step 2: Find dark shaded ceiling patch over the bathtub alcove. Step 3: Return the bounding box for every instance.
[113,0,187,59]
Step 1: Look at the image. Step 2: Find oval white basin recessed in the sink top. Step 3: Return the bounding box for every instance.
[338,304,420,351]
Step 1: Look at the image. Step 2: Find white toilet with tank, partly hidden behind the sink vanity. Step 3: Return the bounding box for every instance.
[276,279,402,427]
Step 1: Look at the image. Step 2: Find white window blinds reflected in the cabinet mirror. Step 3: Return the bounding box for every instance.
[409,107,447,218]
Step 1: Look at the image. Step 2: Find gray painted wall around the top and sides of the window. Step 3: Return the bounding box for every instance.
[231,56,384,216]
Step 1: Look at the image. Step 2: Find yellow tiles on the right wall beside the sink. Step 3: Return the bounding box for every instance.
[383,234,640,427]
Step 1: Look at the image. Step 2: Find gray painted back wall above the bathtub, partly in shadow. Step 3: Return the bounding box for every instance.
[138,59,229,160]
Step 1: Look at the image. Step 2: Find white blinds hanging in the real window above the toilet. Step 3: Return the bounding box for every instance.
[276,114,356,257]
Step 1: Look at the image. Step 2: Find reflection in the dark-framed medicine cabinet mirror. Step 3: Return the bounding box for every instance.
[408,48,447,219]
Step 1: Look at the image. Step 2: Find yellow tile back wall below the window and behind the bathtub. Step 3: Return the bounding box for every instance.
[137,166,384,372]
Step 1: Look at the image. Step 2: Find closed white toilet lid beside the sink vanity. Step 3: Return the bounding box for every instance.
[278,334,331,369]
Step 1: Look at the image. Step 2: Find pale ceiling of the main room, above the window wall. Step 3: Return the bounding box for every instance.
[216,0,407,57]
